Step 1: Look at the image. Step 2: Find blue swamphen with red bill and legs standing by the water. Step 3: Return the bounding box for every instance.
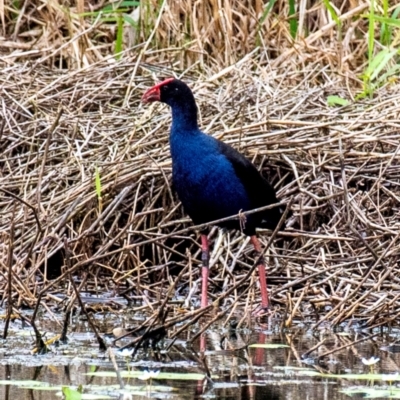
[142,78,282,309]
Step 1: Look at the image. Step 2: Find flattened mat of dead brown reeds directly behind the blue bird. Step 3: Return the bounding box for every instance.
[0,54,400,332]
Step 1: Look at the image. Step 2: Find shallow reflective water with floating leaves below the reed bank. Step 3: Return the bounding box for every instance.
[0,314,400,400]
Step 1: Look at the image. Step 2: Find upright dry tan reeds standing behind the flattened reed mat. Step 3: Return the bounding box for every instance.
[0,0,376,74]
